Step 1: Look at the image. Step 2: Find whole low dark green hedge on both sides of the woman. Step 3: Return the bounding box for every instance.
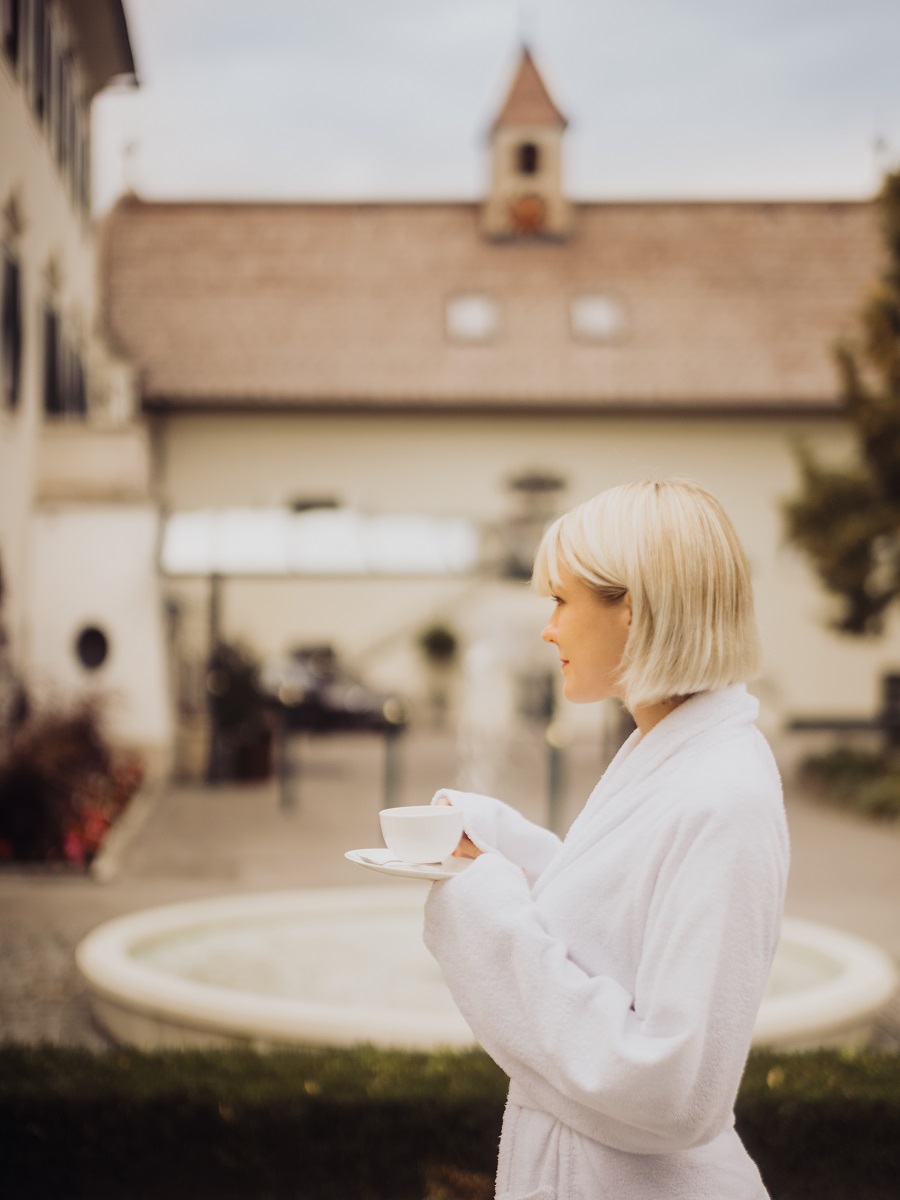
[0,1044,900,1200]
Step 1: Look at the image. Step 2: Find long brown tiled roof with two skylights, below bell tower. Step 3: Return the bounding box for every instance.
[103,189,881,409]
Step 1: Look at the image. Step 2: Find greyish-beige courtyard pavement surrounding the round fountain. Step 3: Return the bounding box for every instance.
[0,731,900,1050]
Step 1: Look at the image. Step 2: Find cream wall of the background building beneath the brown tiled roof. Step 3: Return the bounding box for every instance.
[158,415,900,725]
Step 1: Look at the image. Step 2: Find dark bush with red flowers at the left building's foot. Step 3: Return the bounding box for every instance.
[0,702,144,865]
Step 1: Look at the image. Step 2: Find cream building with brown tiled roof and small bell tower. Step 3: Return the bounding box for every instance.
[17,39,900,777]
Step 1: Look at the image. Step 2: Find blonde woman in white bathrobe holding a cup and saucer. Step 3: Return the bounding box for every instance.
[425,481,788,1200]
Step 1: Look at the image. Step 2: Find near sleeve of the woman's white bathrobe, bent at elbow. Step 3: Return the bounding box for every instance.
[425,796,786,1153]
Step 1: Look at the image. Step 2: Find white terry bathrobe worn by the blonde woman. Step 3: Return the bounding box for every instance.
[425,684,788,1200]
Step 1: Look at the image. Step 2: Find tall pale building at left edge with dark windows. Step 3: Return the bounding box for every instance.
[0,0,170,761]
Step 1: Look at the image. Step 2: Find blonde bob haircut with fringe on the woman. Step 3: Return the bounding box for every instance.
[532,479,760,710]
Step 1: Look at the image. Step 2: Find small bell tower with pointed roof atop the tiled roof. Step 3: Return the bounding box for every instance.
[481,46,572,239]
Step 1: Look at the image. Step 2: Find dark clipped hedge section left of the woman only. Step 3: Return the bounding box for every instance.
[0,1046,505,1200]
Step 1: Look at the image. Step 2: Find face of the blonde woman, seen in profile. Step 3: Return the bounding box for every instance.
[541,566,631,704]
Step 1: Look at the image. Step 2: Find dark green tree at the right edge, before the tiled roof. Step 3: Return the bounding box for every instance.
[784,170,900,635]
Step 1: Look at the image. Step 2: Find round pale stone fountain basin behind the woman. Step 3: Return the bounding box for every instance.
[76,882,896,1049]
